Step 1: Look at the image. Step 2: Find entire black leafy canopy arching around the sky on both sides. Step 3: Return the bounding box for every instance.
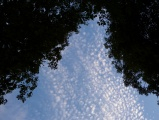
[0,0,159,104]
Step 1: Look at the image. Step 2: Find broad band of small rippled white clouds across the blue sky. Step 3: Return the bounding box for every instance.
[38,17,146,120]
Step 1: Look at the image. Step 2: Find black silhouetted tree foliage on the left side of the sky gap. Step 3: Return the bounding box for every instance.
[0,0,95,104]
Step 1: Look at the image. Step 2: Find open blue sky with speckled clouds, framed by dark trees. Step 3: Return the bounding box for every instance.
[0,18,159,120]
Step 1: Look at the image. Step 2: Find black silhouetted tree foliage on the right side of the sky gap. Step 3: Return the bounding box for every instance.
[105,0,159,103]
